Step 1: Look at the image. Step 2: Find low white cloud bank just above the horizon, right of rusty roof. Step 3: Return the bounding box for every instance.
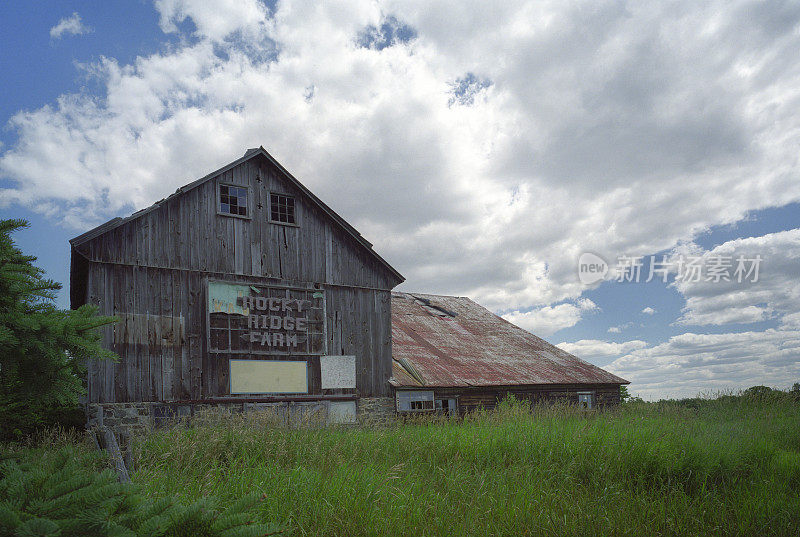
[608,329,800,399]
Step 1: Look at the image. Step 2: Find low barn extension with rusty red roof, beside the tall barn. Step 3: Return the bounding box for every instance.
[390,293,629,413]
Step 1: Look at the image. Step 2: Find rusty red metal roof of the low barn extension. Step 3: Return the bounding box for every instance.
[390,293,629,388]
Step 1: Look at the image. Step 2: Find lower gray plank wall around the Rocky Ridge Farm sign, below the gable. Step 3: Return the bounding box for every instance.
[83,264,391,402]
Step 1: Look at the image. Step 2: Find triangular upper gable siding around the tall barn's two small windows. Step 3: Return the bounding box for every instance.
[77,158,400,289]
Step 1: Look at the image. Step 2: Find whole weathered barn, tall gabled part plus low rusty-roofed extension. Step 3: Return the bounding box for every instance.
[70,147,626,428]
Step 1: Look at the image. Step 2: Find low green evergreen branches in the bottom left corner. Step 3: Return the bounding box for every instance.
[0,447,284,537]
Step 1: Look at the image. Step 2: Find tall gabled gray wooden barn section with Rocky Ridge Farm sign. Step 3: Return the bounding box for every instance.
[70,148,403,426]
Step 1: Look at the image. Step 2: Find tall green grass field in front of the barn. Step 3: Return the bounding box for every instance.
[134,397,800,536]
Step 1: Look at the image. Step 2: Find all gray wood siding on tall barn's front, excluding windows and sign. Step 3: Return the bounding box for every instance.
[78,153,399,402]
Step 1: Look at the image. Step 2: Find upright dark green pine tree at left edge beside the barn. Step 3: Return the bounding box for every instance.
[0,220,116,440]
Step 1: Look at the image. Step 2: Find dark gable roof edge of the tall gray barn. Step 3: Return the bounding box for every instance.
[69,146,405,282]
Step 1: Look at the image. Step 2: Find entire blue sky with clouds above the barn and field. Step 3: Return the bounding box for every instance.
[0,0,800,398]
